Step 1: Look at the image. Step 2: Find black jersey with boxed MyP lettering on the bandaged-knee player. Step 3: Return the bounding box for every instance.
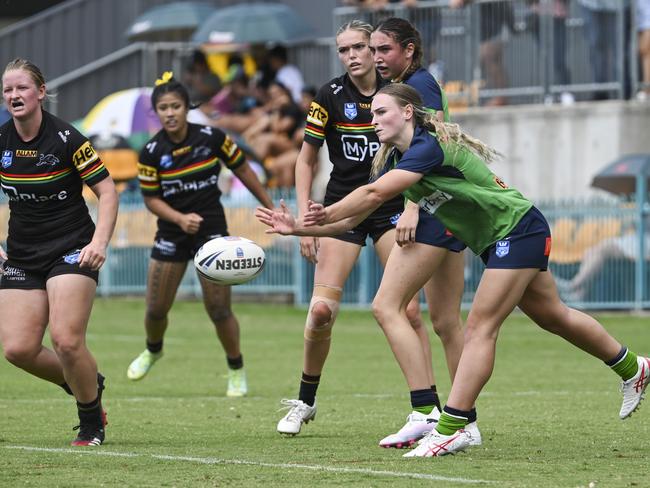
[305,73,404,213]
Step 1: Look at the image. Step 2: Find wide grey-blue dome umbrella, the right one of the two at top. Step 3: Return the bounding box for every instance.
[192,3,313,44]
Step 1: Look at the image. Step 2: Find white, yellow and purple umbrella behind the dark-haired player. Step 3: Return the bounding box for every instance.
[81,88,161,147]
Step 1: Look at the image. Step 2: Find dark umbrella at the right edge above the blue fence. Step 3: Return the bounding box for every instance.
[591,154,650,195]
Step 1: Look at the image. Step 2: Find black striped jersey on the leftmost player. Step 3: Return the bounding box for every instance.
[0,111,108,269]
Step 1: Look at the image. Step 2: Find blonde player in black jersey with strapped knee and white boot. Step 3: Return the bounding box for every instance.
[277,20,429,435]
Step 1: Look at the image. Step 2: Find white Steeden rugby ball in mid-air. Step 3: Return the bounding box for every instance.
[194,236,266,285]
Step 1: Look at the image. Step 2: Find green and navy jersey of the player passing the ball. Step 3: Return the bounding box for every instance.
[393,127,533,254]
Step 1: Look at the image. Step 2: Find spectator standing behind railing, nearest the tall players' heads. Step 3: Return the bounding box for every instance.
[449,0,514,106]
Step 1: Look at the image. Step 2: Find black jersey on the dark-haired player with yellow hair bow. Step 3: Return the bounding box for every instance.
[138,123,245,233]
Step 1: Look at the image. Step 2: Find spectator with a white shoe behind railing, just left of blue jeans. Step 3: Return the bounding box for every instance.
[529,0,575,105]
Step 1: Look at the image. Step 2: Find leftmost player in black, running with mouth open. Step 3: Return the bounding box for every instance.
[0,59,118,446]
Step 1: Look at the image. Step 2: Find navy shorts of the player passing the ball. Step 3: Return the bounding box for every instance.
[481,207,551,271]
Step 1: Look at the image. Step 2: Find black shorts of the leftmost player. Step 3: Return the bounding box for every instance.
[0,248,99,290]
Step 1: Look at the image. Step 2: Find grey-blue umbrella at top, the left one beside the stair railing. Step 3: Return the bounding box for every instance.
[125,2,216,41]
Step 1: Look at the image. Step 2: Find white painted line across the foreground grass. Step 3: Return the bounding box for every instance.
[4,446,492,484]
